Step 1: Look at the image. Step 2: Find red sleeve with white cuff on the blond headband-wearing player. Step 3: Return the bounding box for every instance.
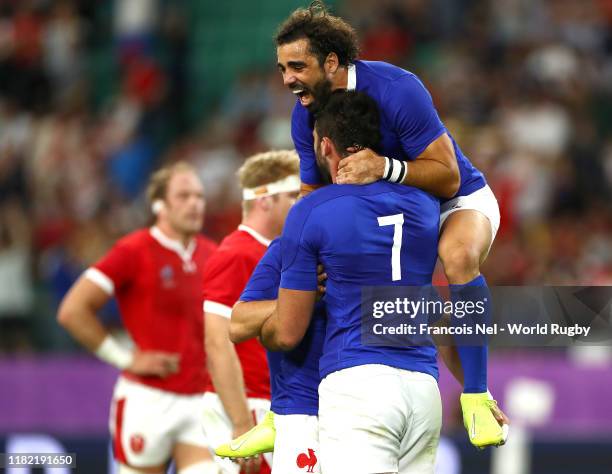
[203,251,256,318]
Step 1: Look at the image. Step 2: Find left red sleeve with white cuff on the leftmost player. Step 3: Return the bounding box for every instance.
[85,240,137,295]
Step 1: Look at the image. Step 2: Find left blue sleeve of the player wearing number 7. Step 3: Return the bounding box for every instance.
[280,198,318,291]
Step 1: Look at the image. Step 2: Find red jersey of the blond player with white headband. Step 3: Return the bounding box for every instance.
[204,225,270,399]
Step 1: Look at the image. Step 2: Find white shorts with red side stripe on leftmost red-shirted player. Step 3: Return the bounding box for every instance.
[109,377,208,468]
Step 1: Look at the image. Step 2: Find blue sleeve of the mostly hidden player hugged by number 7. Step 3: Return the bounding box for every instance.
[240,239,281,301]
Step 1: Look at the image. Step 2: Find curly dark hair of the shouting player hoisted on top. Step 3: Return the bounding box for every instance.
[274,0,359,66]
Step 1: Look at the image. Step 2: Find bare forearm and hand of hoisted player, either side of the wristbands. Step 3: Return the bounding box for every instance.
[337,133,461,198]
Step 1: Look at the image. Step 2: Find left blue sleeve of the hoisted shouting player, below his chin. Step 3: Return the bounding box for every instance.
[291,102,322,184]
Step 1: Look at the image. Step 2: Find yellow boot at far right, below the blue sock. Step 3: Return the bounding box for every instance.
[461,392,510,449]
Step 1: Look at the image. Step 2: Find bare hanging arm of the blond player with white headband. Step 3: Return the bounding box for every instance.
[204,313,254,436]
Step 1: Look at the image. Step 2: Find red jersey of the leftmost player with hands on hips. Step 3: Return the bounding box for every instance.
[86,227,216,394]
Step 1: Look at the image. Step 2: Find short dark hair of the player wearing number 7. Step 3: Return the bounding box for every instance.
[315,90,381,157]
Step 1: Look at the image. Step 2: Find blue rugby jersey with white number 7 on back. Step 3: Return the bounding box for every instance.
[280,181,439,378]
